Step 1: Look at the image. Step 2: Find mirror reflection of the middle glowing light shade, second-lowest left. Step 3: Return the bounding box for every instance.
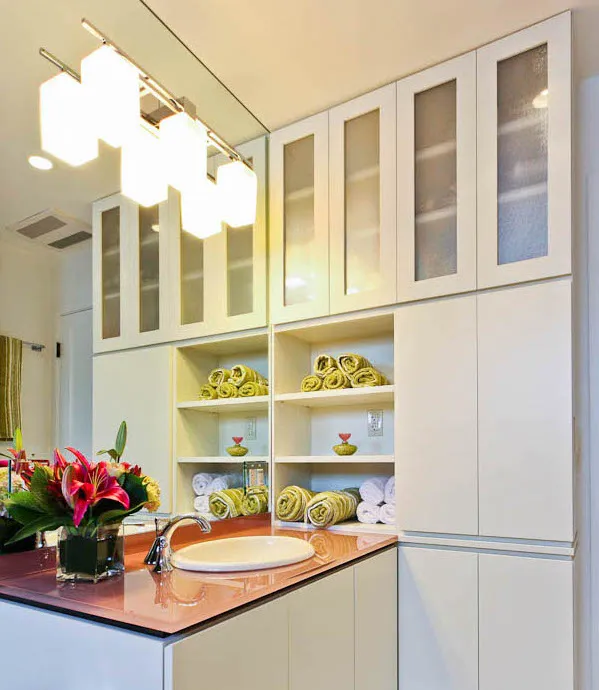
[121,124,168,206]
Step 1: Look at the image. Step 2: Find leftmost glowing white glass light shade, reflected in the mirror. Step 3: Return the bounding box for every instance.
[40,72,98,166]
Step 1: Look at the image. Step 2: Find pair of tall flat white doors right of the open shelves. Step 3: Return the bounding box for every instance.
[396,279,573,541]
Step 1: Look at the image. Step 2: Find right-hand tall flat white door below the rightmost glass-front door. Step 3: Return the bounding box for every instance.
[477,280,573,541]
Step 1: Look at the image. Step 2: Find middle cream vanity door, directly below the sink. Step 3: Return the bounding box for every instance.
[288,568,354,690]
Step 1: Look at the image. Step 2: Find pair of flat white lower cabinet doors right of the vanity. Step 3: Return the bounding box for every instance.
[399,546,574,690]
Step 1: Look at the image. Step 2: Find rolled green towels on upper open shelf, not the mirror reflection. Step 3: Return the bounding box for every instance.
[301,354,389,393]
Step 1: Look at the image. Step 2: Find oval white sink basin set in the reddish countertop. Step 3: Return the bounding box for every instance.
[171,537,314,573]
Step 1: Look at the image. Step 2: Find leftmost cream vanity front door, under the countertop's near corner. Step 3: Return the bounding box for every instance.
[165,597,290,690]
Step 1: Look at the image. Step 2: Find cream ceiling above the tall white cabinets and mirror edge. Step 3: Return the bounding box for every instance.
[145,0,599,130]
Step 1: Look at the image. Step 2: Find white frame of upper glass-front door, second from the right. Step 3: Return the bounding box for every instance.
[397,53,476,302]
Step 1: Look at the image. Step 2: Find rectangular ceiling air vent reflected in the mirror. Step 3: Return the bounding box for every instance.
[6,209,92,249]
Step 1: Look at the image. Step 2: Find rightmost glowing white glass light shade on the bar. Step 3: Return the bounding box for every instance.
[216,161,258,228]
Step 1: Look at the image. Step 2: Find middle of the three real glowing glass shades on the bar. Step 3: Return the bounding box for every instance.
[160,113,208,192]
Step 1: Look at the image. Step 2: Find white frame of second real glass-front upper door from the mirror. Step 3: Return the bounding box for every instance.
[329,84,397,313]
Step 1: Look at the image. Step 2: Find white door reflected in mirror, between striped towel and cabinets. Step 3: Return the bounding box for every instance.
[58,309,93,457]
